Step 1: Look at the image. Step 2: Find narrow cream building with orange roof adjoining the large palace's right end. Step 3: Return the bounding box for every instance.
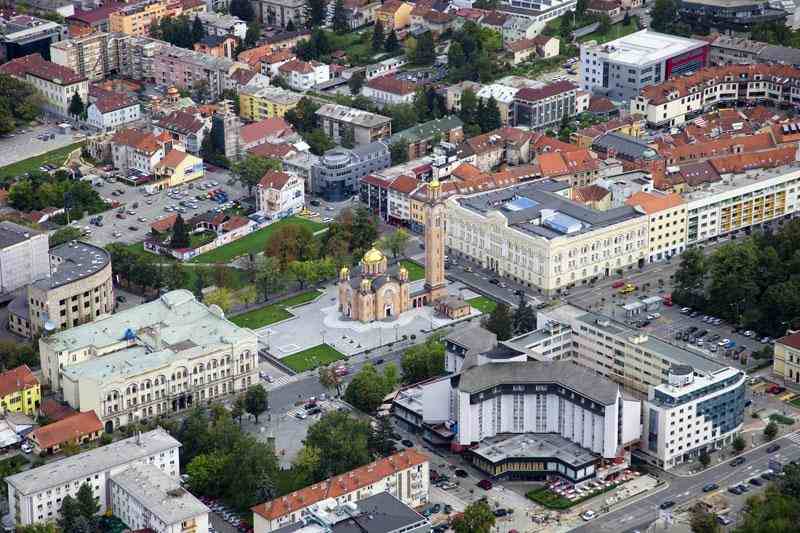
[625,191,686,263]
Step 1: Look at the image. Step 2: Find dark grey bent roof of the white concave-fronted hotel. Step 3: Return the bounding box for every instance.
[458,361,619,405]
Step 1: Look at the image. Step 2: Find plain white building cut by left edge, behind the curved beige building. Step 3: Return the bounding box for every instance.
[0,220,50,294]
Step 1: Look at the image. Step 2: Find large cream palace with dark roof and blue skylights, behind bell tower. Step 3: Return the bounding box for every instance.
[447,180,648,295]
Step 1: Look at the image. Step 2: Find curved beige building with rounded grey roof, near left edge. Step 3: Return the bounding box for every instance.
[8,242,114,337]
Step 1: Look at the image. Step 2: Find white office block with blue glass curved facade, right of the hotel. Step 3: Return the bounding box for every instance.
[641,365,747,470]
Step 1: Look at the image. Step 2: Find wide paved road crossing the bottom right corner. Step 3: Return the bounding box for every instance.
[573,432,800,533]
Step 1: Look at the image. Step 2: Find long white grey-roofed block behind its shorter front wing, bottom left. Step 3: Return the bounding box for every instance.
[5,428,181,533]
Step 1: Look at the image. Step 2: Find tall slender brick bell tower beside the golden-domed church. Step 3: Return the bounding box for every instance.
[425,179,447,301]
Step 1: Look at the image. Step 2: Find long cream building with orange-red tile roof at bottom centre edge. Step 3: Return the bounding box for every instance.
[252,448,429,533]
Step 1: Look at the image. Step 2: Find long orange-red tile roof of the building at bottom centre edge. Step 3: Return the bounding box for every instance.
[252,448,428,520]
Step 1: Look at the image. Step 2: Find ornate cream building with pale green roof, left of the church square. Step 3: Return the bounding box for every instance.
[39,290,258,432]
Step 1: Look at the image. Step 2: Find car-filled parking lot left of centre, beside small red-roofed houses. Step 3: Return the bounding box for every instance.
[78,167,247,246]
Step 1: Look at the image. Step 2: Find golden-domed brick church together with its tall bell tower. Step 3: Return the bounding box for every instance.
[339,180,454,322]
